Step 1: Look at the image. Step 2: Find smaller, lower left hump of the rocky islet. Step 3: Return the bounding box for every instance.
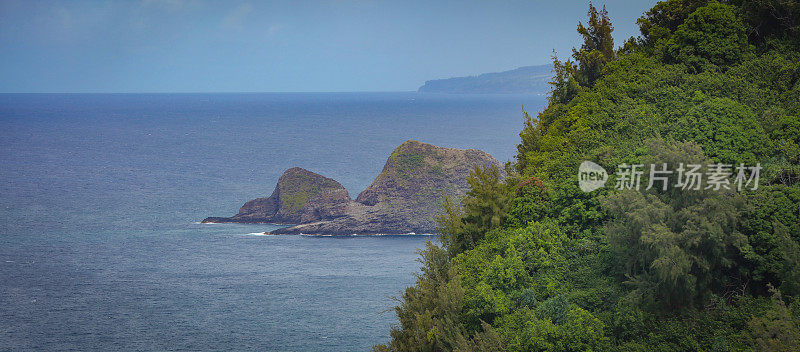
[203,167,351,224]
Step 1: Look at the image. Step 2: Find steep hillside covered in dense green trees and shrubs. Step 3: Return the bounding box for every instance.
[375,0,800,351]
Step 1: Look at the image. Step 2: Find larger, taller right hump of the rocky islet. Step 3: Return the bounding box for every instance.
[274,140,499,234]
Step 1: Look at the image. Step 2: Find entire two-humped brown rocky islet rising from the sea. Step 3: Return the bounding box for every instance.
[203,140,500,235]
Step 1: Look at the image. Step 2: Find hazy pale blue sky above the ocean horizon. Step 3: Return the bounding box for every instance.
[0,0,655,93]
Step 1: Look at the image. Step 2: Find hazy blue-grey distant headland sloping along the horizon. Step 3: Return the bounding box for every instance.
[418,65,553,95]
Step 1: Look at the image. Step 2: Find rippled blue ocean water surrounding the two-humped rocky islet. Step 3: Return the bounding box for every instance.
[0,93,544,351]
